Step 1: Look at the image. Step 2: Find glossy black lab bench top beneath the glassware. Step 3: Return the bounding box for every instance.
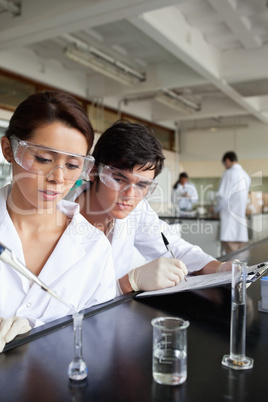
[0,239,268,402]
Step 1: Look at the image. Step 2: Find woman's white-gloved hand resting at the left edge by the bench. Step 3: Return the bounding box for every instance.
[0,316,32,353]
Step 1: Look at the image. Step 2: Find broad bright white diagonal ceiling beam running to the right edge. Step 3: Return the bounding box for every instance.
[130,7,268,124]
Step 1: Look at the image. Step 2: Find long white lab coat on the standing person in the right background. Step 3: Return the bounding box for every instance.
[214,163,250,242]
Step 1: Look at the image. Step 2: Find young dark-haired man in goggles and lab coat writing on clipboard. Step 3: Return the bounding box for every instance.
[68,121,234,293]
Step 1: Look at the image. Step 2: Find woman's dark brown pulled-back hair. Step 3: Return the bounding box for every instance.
[5,91,94,152]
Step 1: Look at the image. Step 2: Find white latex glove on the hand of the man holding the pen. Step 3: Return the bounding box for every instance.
[128,257,188,291]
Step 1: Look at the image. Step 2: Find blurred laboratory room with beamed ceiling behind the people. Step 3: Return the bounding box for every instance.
[0,0,268,257]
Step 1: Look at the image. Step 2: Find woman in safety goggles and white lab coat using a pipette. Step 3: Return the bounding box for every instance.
[0,91,115,351]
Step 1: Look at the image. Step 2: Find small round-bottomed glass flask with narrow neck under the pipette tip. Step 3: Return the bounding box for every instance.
[68,313,88,381]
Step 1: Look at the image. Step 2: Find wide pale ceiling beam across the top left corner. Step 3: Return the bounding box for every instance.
[0,0,182,51]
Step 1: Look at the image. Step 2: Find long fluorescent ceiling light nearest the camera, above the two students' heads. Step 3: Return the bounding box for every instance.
[64,46,146,85]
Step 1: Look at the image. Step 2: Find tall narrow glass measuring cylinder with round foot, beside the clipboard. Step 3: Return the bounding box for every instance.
[222,261,253,370]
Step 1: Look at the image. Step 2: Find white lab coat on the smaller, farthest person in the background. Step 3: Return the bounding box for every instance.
[172,182,198,211]
